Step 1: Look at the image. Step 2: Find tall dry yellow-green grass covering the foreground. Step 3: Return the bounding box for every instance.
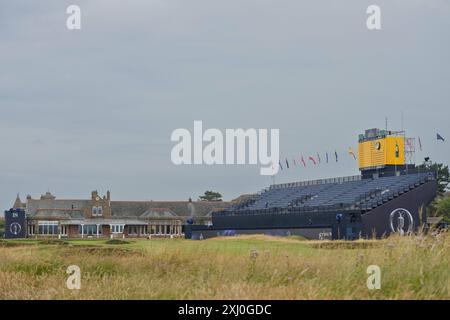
[0,233,450,299]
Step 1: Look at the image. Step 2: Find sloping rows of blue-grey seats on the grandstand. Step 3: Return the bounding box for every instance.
[223,172,434,214]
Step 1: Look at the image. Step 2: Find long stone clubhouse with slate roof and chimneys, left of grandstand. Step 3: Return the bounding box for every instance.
[8,191,230,238]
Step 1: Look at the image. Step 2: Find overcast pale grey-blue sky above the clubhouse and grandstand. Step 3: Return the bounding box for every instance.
[0,0,450,209]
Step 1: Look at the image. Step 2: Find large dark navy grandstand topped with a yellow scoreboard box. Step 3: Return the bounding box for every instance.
[186,129,437,239]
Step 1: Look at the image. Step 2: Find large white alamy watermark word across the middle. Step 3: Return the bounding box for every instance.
[170,121,280,175]
